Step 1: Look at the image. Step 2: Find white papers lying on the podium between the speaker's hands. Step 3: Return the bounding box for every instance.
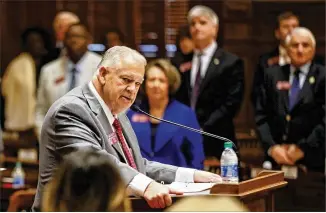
[169,182,216,193]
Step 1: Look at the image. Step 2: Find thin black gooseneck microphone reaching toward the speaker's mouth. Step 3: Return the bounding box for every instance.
[130,104,238,150]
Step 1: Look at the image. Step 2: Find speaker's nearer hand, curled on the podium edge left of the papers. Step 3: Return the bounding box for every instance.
[144,181,183,208]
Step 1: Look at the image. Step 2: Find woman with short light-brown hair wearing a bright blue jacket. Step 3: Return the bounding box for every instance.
[127,59,204,169]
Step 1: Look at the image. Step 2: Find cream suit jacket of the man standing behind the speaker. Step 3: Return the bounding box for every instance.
[35,51,102,139]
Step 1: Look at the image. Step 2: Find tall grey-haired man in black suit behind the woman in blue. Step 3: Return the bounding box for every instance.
[175,5,244,159]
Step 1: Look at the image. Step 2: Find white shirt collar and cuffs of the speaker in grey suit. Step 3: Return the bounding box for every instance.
[88,82,196,196]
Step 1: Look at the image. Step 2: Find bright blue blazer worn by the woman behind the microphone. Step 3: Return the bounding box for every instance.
[127,100,205,169]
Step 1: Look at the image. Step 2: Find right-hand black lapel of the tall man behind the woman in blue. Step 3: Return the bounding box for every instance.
[198,47,223,96]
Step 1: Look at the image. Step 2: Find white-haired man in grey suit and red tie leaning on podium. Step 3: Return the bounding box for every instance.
[33,46,221,210]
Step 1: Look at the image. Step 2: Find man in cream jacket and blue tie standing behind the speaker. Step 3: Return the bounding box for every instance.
[35,23,101,137]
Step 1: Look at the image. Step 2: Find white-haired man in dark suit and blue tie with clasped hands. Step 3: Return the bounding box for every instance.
[256,27,325,172]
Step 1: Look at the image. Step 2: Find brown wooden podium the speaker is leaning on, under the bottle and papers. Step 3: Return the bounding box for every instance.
[131,170,287,212]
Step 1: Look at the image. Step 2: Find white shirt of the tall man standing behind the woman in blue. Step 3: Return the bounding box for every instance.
[190,41,217,87]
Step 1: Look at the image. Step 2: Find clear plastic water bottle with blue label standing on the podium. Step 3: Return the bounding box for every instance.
[221,142,239,183]
